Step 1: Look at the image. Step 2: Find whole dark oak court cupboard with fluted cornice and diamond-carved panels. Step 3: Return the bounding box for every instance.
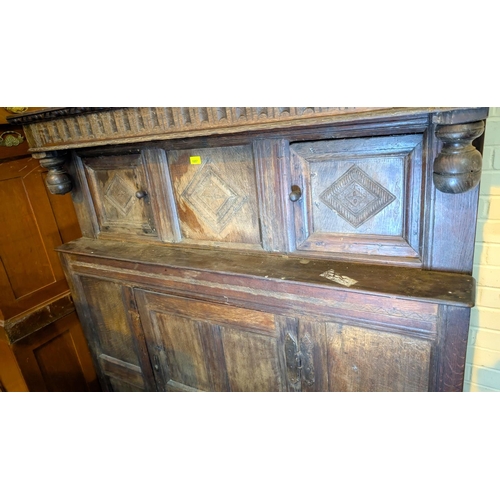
[12,107,488,391]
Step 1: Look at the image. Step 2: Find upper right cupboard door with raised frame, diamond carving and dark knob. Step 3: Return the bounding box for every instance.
[290,135,425,266]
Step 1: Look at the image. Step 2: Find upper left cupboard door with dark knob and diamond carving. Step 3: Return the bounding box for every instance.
[79,149,179,241]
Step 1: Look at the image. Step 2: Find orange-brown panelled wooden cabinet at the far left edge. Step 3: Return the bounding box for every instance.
[0,108,99,391]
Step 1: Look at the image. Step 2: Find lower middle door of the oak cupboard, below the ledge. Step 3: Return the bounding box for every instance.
[135,290,294,392]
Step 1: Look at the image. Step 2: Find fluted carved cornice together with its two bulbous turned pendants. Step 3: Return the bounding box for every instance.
[8,107,488,194]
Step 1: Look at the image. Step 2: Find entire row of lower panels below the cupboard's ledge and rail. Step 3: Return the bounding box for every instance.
[75,276,436,392]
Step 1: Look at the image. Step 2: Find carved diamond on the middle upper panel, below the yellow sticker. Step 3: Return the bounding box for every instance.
[181,164,246,234]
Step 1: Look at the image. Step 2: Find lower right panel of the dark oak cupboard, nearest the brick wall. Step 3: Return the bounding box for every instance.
[297,320,433,392]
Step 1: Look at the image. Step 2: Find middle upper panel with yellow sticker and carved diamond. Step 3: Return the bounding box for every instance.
[168,146,262,248]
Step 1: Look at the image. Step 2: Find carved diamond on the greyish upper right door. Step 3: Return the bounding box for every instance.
[320,165,396,228]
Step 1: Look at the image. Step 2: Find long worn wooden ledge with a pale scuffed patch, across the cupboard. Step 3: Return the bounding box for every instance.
[58,238,474,307]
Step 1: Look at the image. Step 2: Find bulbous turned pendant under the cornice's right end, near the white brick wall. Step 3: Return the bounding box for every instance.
[433,121,484,194]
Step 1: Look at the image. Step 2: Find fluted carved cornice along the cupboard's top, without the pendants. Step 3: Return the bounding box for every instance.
[9,107,482,152]
